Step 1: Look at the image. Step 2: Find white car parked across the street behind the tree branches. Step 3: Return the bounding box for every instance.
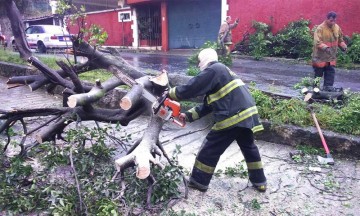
[11,25,72,53]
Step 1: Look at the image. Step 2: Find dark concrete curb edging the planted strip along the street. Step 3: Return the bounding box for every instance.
[0,62,360,157]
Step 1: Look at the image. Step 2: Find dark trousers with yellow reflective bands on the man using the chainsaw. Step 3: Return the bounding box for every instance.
[190,127,266,188]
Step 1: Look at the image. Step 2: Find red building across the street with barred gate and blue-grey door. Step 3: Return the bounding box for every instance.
[66,0,360,51]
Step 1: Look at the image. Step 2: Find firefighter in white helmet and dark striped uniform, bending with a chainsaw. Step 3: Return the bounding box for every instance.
[169,48,266,192]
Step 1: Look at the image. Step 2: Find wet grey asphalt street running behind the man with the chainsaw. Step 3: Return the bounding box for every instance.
[114,50,360,95]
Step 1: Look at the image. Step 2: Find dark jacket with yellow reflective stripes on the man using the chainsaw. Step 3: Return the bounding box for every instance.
[169,62,264,132]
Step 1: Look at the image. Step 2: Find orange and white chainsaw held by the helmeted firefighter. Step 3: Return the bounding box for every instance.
[112,67,185,127]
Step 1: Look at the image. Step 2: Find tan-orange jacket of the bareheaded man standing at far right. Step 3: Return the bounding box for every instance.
[312,21,347,67]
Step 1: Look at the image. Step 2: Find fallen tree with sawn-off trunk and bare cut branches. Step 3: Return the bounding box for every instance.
[0,0,187,209]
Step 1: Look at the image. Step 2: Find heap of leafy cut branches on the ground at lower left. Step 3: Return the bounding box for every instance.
[0,125,183,215]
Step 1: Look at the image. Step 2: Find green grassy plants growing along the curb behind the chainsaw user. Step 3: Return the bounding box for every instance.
[250,82,360,135]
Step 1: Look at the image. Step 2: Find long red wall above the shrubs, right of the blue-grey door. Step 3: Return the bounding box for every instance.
[227,0,360,43]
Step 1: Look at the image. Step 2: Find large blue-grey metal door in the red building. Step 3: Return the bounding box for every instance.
[168,0,221,49]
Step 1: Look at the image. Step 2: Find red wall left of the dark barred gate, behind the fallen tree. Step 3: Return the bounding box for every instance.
[69,10,133,46]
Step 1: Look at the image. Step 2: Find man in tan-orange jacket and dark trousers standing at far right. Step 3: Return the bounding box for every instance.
[312,11,347,91]
